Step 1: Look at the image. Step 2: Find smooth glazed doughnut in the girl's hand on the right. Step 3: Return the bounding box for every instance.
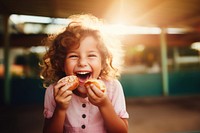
[84,79,106,92]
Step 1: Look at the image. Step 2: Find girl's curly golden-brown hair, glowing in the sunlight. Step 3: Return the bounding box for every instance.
[41,14,123,87]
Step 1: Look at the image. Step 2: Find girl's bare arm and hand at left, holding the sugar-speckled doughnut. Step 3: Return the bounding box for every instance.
[43,83,72,133]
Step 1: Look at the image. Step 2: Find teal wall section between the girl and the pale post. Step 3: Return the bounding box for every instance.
[120,74,162,97]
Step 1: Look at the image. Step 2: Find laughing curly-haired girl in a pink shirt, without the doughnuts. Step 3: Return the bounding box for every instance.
[41,14,129,133]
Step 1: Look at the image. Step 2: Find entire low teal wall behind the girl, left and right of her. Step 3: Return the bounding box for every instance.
[0,71,200,105]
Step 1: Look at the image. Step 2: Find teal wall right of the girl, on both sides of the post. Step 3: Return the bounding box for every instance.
[120,71,200,97]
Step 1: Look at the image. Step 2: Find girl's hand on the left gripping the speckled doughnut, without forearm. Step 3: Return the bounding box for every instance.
[54,82,72,110]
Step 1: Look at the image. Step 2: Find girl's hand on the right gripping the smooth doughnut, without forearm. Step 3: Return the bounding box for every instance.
[86,84,107,107]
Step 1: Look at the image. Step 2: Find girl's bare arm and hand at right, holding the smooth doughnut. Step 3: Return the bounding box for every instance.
[87,85,128,133]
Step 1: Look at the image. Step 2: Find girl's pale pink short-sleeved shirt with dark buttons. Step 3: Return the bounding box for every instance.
[44,80,129,133]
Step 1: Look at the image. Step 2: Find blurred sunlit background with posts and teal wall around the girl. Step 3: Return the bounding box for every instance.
[0,0,200,133]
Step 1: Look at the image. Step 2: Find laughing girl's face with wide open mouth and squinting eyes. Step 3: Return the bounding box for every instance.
[64,36,102,93]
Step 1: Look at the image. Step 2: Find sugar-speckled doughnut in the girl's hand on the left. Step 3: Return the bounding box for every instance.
[58,75,79,91]
